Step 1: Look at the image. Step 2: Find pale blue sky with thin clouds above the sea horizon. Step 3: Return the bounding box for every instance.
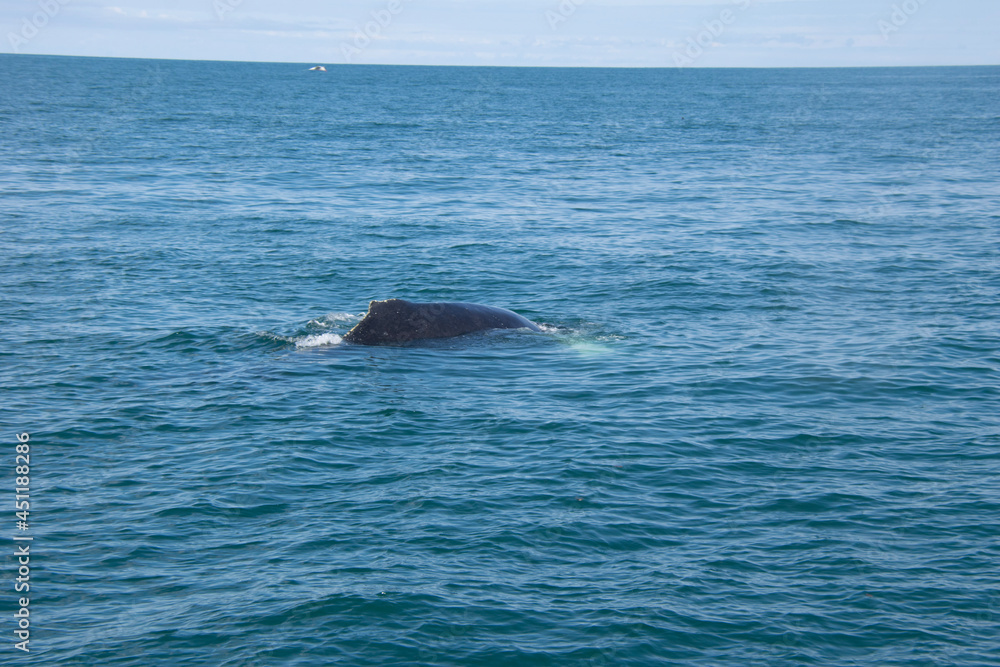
[0,0,1000,67]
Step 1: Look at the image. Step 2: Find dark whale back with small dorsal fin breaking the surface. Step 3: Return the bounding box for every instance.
[344,299,541,345]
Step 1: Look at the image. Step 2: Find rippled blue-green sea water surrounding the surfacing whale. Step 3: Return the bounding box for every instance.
[0,55,1000,666]
